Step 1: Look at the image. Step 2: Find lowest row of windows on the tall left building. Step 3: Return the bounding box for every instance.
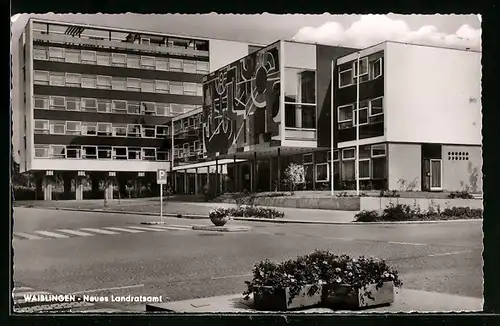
[35,144,170,162]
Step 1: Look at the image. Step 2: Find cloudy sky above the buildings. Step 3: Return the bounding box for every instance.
[11,13,481,162]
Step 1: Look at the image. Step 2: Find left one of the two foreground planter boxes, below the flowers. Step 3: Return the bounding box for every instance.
[253,285,322,311]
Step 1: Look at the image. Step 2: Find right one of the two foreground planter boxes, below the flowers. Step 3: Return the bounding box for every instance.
[323,282,394,309]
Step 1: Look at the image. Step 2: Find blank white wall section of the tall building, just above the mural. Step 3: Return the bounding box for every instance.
[209,40,254,72]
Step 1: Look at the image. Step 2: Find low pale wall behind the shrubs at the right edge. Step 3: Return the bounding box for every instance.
[359,197,483,211]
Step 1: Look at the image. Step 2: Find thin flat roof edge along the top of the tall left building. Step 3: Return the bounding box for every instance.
[26,17,266,47]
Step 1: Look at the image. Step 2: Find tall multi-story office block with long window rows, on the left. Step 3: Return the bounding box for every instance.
[14,19,266,199]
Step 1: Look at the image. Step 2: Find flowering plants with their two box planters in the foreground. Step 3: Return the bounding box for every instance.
[243,250,402,310]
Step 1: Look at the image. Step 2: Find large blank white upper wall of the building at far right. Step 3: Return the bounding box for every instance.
[384,42,482,145]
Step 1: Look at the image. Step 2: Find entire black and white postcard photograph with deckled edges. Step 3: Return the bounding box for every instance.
[10,13,484,315]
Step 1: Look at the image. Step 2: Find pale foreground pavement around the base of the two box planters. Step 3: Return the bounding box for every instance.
[146,289,483,313]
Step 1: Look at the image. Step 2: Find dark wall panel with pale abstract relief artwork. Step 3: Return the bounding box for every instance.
[203,43,281,155]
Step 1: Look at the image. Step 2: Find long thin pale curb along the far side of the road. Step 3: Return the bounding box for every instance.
[17,206,482,225]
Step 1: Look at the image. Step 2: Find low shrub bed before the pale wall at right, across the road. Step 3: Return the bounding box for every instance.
[354,204,483,222]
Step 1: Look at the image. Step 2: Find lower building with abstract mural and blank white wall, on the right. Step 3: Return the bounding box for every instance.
[171,41,482,192]
